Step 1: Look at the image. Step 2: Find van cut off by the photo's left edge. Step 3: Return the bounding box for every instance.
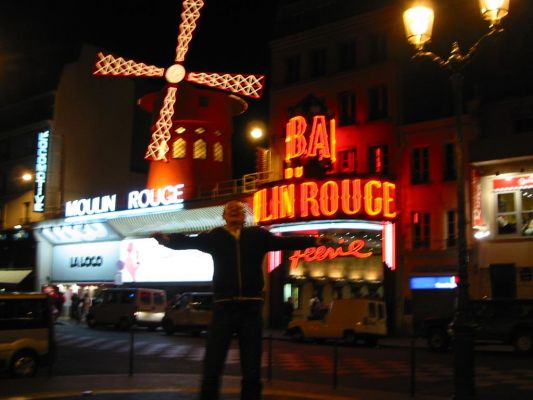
[0,293,56,377]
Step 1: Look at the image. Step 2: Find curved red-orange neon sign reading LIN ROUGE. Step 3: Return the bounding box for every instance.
[253,179,397,223]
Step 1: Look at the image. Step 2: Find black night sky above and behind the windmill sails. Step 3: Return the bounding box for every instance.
[0,0,276,176]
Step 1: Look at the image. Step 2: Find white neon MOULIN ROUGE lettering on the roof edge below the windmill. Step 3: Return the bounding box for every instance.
[65,184,184,217]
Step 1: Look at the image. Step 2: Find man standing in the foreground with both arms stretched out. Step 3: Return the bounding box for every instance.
[152,200,329,400]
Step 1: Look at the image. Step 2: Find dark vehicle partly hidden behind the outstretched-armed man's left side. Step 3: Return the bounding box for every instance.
[162,292,213,335]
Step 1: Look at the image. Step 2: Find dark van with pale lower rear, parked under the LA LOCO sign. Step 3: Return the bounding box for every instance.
[86,288,167,330]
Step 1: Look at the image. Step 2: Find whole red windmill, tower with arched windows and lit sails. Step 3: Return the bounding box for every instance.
[93,0,264,199]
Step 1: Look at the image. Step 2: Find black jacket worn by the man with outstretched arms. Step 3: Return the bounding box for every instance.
[165,226,315,300]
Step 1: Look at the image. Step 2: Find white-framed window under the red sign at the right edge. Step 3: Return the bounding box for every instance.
[496,189,533,237]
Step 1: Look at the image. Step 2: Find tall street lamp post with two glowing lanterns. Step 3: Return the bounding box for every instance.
[403,0,509,400]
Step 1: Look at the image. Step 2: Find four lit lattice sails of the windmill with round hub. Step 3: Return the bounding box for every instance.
[93,0,264,161]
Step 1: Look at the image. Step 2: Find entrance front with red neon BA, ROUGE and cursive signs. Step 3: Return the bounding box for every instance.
[253,115,397,327]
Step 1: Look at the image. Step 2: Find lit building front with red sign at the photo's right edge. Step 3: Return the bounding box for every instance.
[472,173,533,298]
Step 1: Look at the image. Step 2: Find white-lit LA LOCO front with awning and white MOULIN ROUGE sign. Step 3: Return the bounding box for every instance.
[34,185,252,315]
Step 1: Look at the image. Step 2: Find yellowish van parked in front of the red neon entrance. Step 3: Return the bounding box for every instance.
[287,298,387,346]
